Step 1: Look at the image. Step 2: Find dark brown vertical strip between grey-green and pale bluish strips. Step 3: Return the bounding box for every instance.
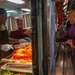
[42,0,49,75]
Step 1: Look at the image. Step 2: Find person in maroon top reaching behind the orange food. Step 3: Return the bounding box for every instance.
[10,19,31,41]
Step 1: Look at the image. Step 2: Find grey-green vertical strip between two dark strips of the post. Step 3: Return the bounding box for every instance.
[37,0,43,75]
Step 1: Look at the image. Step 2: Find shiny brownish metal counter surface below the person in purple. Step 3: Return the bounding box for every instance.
[55,43,75,75]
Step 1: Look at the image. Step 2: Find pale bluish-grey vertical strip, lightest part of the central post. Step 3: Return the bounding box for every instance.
[49,0,55,75]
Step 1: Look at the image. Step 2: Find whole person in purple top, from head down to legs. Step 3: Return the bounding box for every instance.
[56,10,75,75]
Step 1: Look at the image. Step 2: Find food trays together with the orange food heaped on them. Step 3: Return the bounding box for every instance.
[0,43,32,74]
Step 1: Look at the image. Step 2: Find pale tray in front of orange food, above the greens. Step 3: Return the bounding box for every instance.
[1,63,32,73]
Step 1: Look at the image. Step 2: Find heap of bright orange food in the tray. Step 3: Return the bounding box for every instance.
[12,43,32,62]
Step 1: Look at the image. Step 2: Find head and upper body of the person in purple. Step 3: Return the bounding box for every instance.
[56,10,75,51]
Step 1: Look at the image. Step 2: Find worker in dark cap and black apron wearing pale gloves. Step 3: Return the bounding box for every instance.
[0,8,26,59]
